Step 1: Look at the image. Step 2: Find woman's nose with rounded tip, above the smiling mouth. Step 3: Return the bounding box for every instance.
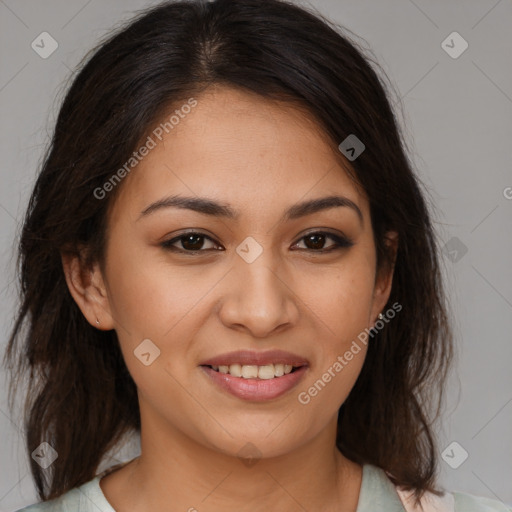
[218,250,300,338]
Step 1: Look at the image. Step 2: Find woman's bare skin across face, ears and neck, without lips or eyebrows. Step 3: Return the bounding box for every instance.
[63,86,396,512]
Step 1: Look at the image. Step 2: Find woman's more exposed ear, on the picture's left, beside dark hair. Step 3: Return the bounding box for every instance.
[61,251,114,331]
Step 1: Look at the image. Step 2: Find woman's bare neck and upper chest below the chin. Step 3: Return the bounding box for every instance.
[101,412,362,512]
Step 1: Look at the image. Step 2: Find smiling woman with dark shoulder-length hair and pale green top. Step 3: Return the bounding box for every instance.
[6,0,507,512]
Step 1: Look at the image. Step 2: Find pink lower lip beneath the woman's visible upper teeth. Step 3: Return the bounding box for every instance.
[200,366,307,401]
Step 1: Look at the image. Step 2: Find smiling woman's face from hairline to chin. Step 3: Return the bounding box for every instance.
[68,87,391,457]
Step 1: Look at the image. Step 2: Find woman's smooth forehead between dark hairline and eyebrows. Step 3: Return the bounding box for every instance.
[112,87,365,223]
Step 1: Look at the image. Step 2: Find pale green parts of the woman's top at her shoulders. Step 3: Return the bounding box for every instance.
[16,464,512,512]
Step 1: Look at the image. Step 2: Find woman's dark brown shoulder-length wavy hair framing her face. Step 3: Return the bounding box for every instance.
[5,0,453,500]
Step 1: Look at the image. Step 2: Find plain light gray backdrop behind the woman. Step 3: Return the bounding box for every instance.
[0,0,512,511]
